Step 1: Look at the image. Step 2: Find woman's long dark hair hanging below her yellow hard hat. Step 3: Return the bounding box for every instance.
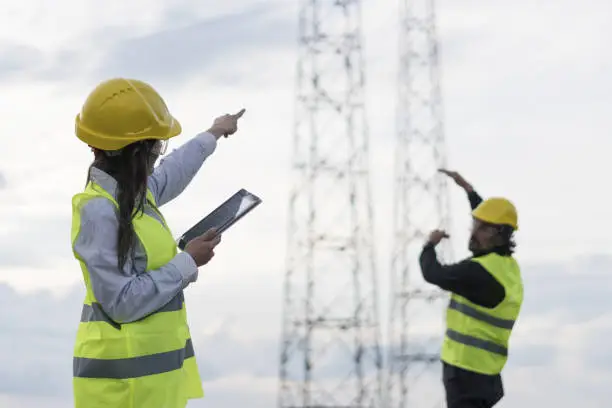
[87,140,156,269]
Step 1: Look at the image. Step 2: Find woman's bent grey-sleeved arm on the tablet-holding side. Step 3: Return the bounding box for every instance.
[73,198,198,323]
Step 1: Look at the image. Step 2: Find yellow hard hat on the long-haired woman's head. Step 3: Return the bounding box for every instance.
[75,78,182,150]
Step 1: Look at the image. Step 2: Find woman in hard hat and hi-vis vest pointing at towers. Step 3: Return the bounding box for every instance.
[71,78,244,408]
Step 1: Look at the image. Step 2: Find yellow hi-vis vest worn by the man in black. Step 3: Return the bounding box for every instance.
[441,254,523,375]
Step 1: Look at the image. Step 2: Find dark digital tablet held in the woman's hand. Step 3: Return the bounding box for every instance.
[178,189,261,251]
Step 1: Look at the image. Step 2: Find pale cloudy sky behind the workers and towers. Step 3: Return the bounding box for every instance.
[0,0,612,408]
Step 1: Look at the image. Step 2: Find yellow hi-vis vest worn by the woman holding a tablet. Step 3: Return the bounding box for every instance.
[72,182,203,408]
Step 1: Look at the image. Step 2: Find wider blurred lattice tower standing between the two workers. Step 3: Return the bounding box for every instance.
[278,0,382,408]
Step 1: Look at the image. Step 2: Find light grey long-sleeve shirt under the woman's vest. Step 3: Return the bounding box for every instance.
[73,132,217,323]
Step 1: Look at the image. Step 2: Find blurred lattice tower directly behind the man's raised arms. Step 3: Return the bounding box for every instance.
[387,0,451,408]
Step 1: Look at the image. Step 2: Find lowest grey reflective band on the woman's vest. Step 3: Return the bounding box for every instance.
[72,339,194,380]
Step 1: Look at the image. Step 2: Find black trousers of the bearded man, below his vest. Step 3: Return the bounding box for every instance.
[442,362,504,408]
